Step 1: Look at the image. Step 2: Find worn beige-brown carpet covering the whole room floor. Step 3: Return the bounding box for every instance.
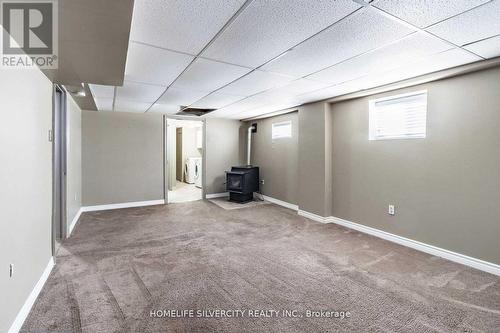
[22,201,500,333]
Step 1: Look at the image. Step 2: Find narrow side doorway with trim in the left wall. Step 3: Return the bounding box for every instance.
[52,85,67,254]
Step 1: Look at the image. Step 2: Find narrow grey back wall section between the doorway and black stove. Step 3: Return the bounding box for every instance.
[203,118,242,194]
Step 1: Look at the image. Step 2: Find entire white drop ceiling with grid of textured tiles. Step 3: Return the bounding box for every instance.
[90,0,500,119]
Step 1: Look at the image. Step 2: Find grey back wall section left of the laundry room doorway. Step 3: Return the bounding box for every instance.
[82,111,163,206]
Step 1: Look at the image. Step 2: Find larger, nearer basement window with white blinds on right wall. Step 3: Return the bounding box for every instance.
[369,90,427,140]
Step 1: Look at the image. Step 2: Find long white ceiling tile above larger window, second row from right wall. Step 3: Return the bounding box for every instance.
[307,32,452,84]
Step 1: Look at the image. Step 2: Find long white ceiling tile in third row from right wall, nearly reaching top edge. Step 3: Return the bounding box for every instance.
[263,8,414,77]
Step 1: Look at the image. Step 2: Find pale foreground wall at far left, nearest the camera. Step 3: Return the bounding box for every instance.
[0,69,52,332]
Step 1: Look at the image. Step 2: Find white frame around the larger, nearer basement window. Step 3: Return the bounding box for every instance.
[368,90,428,141]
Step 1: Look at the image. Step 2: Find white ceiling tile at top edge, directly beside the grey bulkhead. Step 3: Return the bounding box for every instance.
[130,0,245,54]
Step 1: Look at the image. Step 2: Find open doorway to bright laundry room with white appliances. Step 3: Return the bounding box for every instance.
[165,117,204,203]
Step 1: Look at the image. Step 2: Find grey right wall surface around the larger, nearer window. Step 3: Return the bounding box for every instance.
[330,68,500,264]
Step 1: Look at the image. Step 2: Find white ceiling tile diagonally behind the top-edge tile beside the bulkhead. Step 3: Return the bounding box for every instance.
[173,58,251,91]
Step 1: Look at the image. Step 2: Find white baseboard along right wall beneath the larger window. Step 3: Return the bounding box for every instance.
[328,212,500,276]
